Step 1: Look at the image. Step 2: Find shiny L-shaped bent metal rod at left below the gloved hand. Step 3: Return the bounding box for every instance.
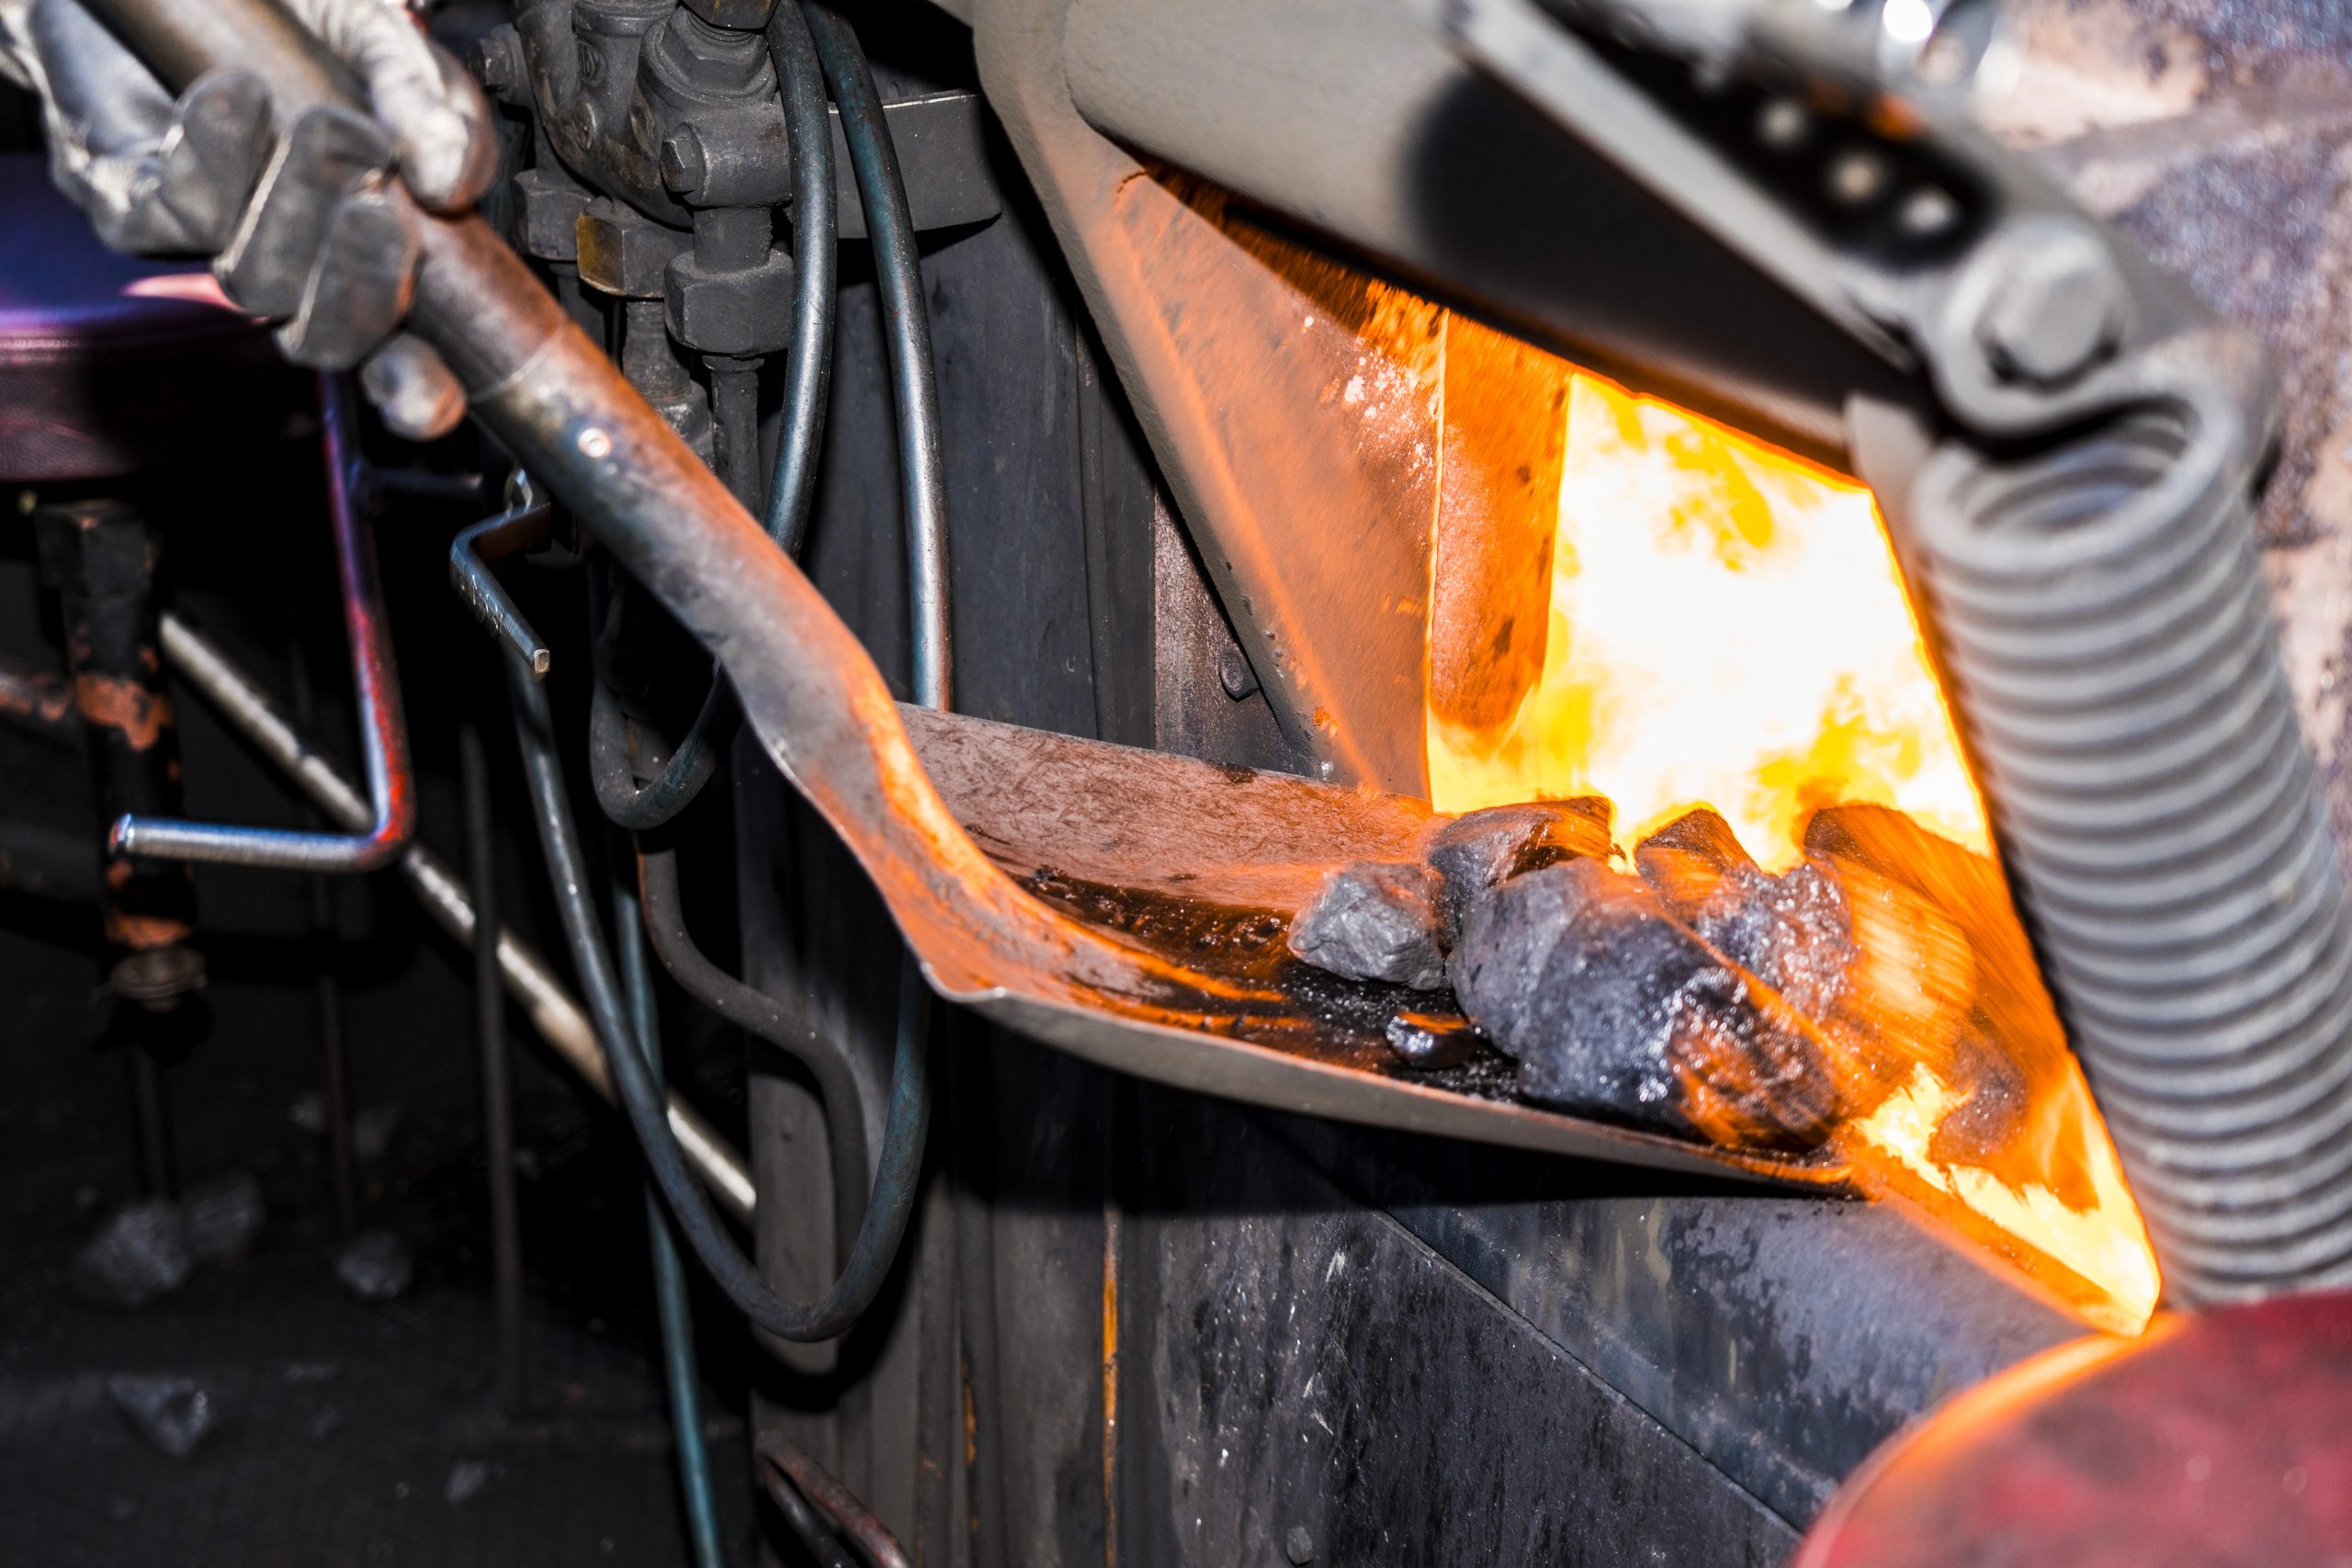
[108,376,416,872]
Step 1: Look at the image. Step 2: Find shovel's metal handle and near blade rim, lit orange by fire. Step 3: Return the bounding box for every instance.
[83,0,1835,1180]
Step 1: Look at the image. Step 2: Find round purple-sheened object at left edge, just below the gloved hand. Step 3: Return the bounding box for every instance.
[0,152,308,484]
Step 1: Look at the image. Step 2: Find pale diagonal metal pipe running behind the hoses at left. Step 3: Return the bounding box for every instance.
[160,611,755,1224]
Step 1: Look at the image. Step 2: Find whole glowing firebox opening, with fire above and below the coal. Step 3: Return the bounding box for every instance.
[1425,350,2159,1333]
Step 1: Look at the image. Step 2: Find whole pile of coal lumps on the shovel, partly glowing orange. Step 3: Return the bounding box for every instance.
[1289,799,2067,1166]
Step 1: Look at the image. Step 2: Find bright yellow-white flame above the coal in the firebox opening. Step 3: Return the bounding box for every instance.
[1428,371,1990,870]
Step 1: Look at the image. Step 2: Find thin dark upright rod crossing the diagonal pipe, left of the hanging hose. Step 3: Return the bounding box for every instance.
[457,722,526,1416]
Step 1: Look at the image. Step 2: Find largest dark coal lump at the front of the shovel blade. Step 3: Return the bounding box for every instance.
[1453,861,1837,1149]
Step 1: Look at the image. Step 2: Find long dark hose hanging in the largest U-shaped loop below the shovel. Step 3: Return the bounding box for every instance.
[505,656,932,1340]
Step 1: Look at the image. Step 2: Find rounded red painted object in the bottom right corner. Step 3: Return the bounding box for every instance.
[1790,1293,2352,1568]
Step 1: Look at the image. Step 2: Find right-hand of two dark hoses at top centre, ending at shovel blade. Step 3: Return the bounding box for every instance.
[802,5,955,707]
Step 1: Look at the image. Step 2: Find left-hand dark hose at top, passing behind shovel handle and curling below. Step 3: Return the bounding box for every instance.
[588,5,837,832]
